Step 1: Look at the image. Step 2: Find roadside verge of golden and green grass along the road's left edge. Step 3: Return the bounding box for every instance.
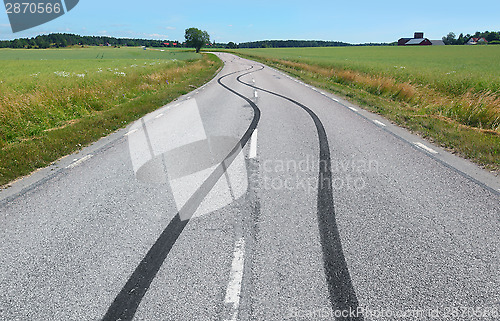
[0,55,222,186]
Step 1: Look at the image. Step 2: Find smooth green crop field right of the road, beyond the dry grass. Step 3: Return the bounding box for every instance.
[238,46,500,94]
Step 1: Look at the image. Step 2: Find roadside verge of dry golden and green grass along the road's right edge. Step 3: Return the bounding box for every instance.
[226,48,500,174]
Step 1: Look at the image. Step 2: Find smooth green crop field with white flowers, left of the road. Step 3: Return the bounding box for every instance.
[0,47,200,86]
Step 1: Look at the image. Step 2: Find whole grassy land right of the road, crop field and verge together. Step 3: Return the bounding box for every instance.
[233,46,500,171]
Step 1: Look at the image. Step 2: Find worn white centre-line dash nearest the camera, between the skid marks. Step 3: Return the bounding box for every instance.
[224,237,245,321]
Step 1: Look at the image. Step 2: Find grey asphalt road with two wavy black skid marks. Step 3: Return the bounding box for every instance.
[0,53,500,321]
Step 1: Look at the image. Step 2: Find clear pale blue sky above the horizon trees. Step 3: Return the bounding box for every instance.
[0,0,500,43]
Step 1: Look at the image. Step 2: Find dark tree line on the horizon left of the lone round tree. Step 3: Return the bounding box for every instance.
[0,33,183,49]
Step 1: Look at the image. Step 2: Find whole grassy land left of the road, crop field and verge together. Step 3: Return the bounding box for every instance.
[0,47,221,185]
